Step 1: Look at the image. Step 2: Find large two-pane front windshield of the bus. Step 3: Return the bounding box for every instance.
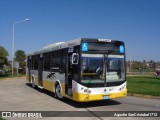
[81,54,125,84]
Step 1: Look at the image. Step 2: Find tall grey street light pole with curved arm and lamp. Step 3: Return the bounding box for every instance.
[12,19,29,76]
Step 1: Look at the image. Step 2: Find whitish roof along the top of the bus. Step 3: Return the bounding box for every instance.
[27,38,122,56]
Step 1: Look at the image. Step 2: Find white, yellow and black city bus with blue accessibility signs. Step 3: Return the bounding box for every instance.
[26,38,127,102]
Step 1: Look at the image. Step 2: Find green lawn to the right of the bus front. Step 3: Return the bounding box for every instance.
[127,76,160,96]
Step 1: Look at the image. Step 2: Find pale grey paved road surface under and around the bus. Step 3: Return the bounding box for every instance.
[0,79,160,120]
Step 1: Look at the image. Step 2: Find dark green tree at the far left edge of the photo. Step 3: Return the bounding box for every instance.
[0,46,8,68]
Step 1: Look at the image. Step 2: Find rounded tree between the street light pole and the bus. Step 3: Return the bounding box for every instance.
[15,50,26,69]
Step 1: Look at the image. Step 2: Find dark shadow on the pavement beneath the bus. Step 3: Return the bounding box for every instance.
[26,83,121,108]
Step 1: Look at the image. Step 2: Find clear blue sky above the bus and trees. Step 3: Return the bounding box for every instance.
[0,0,160,61]
